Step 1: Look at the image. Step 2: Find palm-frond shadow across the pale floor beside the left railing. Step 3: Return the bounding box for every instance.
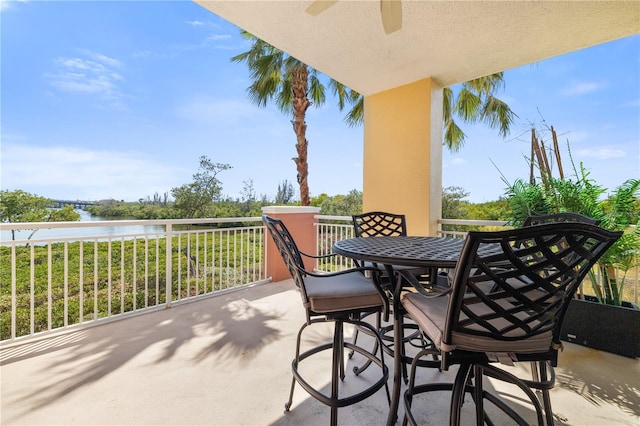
[0,285,288,421]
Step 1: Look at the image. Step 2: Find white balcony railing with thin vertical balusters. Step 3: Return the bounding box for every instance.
[0,215,639,341]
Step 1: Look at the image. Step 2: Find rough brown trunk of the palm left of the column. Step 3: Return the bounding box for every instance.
[291,65,311,206]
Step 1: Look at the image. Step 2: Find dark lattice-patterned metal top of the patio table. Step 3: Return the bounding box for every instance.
[333,237,464,268]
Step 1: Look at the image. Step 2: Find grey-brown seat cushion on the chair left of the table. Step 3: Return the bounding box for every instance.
[305,272,384,313]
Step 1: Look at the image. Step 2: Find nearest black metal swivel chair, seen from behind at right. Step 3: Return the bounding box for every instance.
[398,222,622,425]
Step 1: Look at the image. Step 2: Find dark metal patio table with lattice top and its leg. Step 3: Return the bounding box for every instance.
[333,236,464,425]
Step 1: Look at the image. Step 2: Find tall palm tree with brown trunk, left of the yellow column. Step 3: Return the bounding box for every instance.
[231,30,358,206]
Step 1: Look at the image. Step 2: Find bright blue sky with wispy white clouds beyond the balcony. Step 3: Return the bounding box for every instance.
[0,0,640,202]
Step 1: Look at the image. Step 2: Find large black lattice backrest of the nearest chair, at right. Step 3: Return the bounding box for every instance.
[443,222,621,360]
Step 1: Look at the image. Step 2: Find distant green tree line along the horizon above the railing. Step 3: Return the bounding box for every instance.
[0,181,510,230]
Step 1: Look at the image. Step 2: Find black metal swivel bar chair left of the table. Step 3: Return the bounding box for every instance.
[262,215,390,425]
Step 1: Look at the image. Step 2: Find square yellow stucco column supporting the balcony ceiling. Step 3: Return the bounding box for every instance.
[363,78,442,235]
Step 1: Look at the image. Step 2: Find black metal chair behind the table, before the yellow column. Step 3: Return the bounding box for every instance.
[350,211,437,382]
